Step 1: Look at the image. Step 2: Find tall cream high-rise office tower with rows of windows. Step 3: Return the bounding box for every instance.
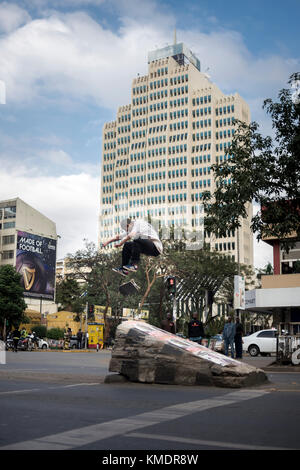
[99,39,253,265]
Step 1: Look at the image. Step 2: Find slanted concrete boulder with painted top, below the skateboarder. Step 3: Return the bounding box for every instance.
[109,321,267,388]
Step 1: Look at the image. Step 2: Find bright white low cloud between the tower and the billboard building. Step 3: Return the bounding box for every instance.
[0,168,99,258]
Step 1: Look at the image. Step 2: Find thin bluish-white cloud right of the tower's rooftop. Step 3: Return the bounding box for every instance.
[181,30,300,99]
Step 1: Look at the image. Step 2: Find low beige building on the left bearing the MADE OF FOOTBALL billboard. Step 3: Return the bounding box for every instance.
[0,198,57,314]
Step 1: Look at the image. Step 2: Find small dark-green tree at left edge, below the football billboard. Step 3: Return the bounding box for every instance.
[0,265,27,329]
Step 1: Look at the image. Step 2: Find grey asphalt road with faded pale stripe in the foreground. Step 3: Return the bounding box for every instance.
[0,351,300,452]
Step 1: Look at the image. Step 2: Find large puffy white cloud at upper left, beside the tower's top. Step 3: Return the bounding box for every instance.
[0,12,150,107]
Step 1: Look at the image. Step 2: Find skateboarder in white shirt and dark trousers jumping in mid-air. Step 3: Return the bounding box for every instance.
[102,219,163,276]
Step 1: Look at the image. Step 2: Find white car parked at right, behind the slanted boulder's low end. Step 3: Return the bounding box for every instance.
[243,329,277,357]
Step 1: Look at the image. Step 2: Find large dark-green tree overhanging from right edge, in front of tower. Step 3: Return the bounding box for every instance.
[203,73,300,244]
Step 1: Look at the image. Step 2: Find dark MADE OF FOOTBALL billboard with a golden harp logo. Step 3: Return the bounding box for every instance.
[16,231,56,300]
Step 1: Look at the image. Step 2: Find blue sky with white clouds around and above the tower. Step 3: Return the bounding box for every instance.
[0,0,300,266]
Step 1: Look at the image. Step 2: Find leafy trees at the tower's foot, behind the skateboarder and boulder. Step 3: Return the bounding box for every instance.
[59,239,253,332]
